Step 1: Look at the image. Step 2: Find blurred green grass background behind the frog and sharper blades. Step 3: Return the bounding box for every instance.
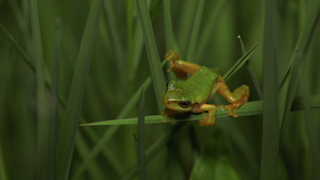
[0,0,320,180]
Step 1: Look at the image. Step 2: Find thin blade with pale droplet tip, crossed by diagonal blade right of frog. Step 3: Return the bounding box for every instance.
[238,35,262,100]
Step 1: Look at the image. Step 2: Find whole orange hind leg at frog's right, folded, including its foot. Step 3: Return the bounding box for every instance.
[217,75,250,117]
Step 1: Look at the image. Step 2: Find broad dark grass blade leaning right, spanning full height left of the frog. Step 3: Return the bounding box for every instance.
[57,0,103,180]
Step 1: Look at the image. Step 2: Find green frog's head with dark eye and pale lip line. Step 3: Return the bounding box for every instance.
[162,80,193,111]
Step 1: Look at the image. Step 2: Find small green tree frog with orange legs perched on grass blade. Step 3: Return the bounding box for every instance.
[161,50,250,126]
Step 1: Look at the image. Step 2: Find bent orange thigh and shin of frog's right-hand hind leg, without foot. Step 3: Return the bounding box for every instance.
[217,76,249,105]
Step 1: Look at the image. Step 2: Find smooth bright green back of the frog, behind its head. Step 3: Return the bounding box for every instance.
[183,66,219,103]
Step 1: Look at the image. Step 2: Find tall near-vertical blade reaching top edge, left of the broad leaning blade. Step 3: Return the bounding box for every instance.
[30,0,51,179]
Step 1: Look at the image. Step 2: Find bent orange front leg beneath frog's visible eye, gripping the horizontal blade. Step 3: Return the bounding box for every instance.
[192,104,217,126]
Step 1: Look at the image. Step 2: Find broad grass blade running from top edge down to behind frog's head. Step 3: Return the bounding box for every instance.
[137,0,165,112]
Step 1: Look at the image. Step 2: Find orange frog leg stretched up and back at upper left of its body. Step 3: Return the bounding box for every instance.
[164,50,201,79]
